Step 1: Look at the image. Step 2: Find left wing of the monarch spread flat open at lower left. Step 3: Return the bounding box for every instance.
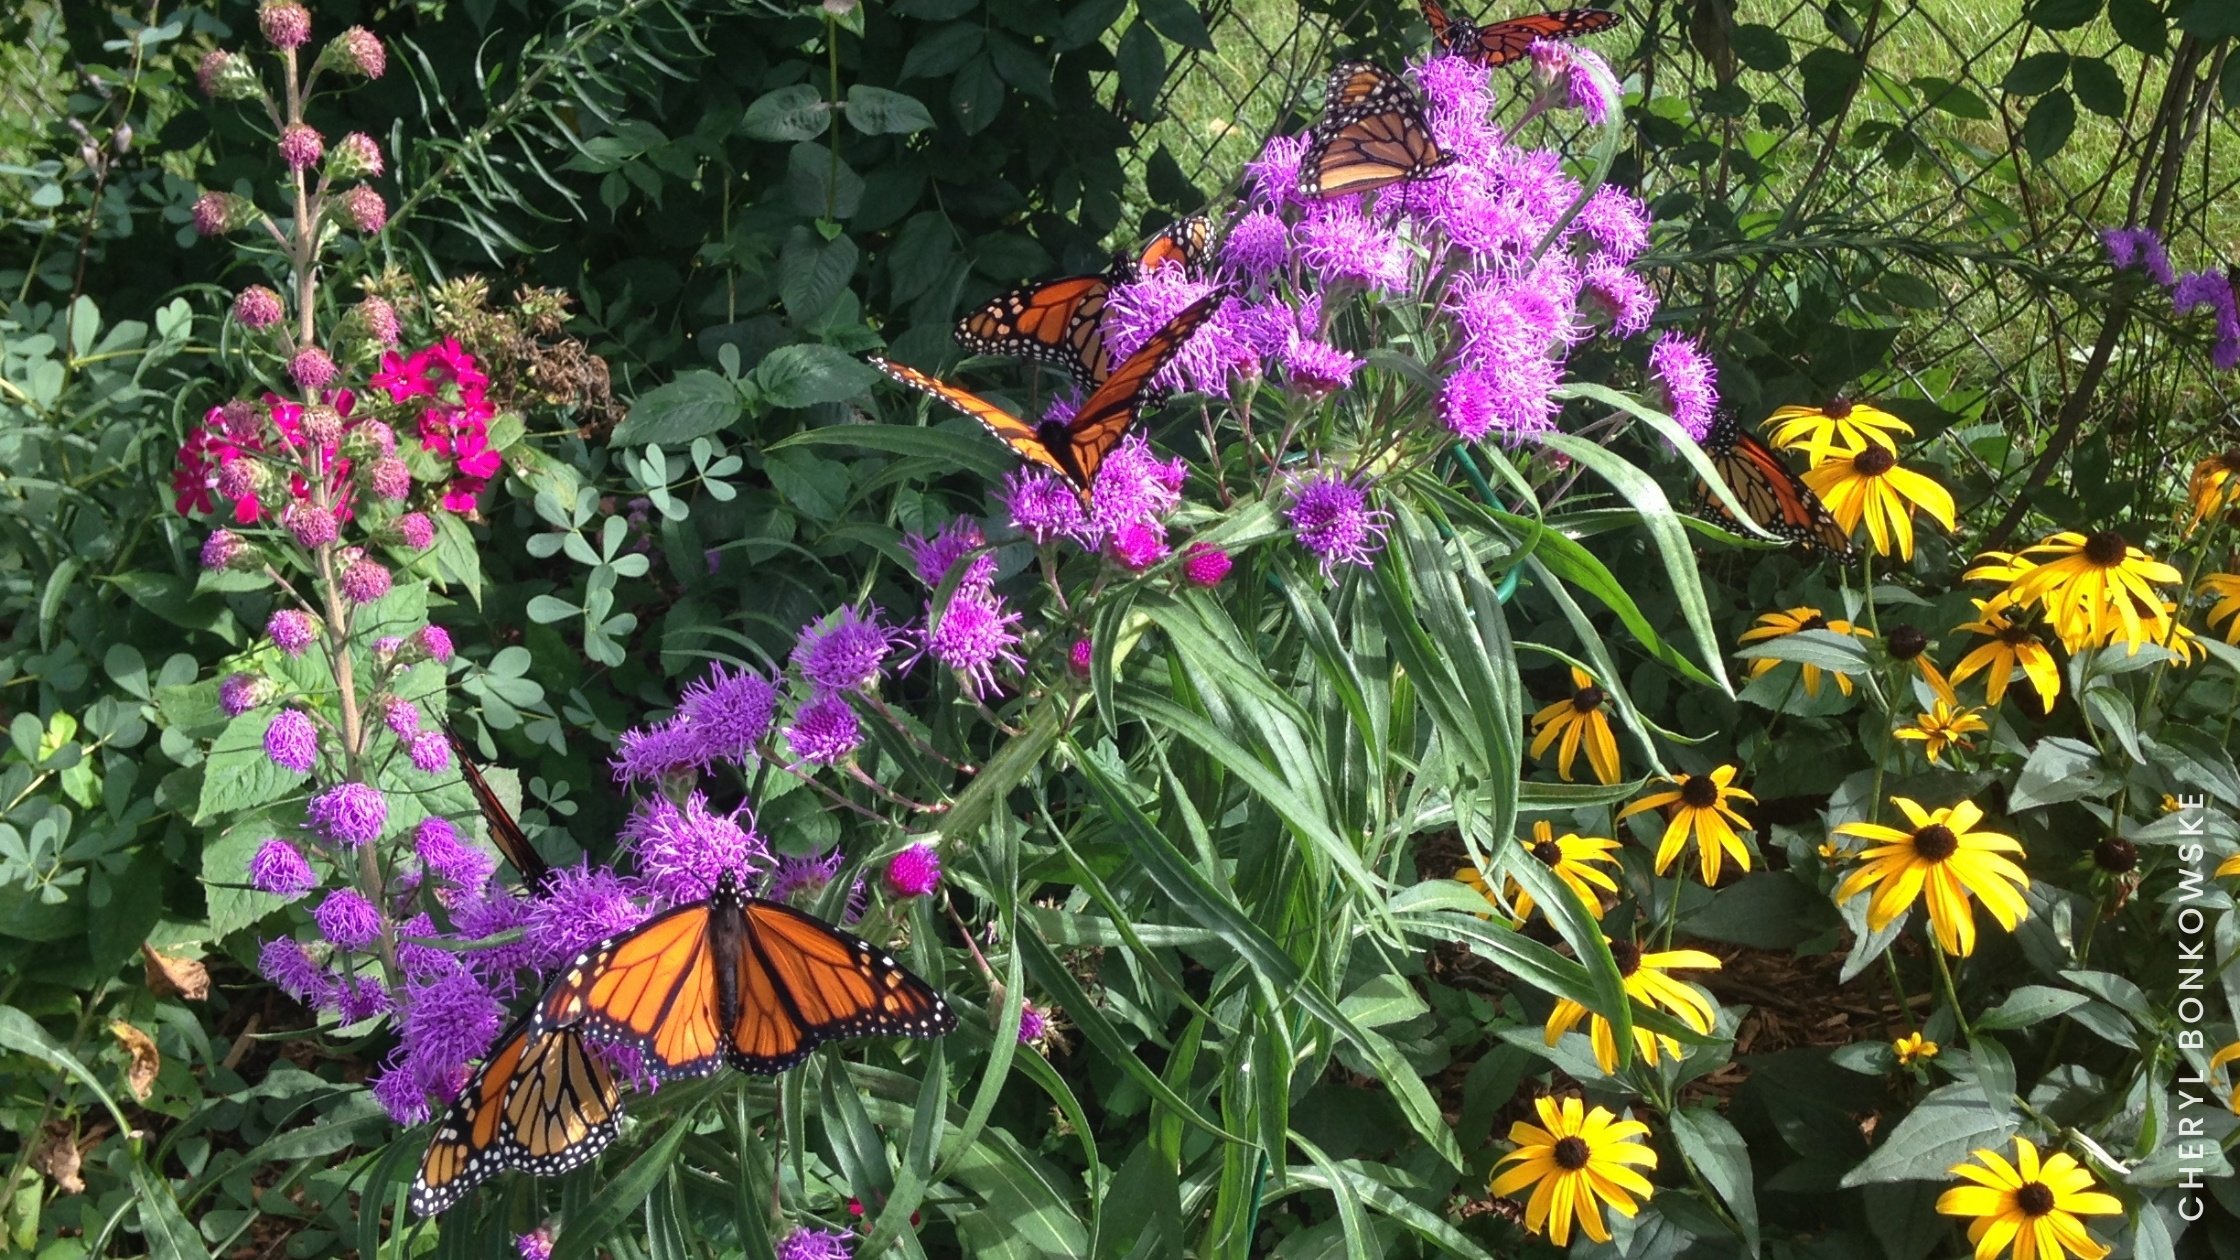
[531,901,724,1081]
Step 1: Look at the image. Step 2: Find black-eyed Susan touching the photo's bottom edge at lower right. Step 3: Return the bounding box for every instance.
[1938,1137,2124,1260]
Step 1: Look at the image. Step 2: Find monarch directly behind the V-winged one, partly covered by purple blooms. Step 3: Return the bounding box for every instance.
[956,215,1214,390]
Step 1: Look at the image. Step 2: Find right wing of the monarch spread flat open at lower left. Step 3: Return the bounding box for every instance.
[728,897,956,1074]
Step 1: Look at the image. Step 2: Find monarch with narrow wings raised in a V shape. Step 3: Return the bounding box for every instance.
[871,291,1221,504]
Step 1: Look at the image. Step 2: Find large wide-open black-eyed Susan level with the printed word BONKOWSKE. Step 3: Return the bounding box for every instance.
[1835,796,2029,957]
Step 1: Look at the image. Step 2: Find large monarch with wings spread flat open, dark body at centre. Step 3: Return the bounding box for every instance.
[531,870,956,1081]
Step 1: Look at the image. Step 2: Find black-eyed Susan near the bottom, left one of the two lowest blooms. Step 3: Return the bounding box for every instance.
[1487,1096,1658,1247]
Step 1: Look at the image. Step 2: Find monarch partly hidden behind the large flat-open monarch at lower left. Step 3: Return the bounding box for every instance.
[405,726,623,1217]
